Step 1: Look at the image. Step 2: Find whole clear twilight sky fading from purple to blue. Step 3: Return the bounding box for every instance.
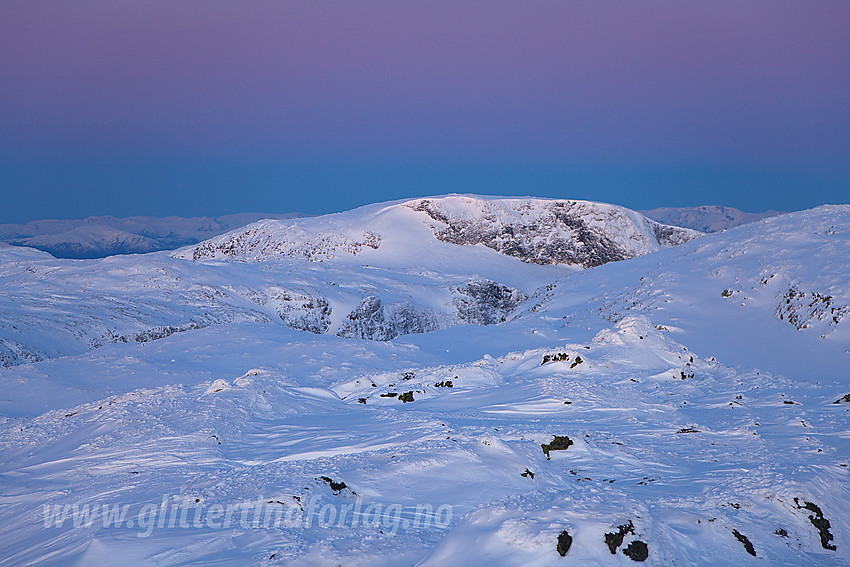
[0,0,850,223]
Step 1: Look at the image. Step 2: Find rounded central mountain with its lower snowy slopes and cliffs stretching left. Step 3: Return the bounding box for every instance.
[0,196,697,366]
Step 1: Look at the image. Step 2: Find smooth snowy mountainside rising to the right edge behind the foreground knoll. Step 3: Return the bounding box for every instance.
[523,205,850,377]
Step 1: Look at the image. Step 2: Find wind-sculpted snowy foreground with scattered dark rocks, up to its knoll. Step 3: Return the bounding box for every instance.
[0,316,850,567]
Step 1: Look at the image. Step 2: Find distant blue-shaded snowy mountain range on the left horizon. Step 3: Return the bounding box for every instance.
[0,213,301,258]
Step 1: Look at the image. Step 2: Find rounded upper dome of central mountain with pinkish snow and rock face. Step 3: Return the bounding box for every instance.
[175,195,701,268]
